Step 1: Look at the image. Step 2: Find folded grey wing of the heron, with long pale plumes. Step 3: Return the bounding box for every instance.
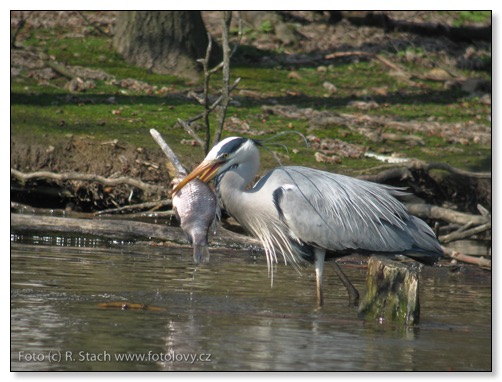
[272,166,441,258]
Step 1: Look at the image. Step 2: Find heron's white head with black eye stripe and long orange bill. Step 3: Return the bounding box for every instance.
[173,137,259,192]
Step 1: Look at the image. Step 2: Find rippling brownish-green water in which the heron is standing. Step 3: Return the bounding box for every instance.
[11,235,492,371]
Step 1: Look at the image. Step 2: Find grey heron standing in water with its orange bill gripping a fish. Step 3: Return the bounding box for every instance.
[173,137,443,306]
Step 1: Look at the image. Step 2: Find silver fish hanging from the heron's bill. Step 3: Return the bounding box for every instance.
[173,178,220,264]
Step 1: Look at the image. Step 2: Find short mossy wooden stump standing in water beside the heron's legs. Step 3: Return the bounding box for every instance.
[359,256,420,325]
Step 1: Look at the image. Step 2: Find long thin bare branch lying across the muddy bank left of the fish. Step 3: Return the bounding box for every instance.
[10,168,162,192]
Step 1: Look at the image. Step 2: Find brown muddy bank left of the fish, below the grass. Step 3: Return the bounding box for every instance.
[11,136,171,212]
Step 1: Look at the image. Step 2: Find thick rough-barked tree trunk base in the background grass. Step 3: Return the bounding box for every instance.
[113,11,215,80]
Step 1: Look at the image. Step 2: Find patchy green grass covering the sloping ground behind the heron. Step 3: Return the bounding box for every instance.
[11,12,491,172]
